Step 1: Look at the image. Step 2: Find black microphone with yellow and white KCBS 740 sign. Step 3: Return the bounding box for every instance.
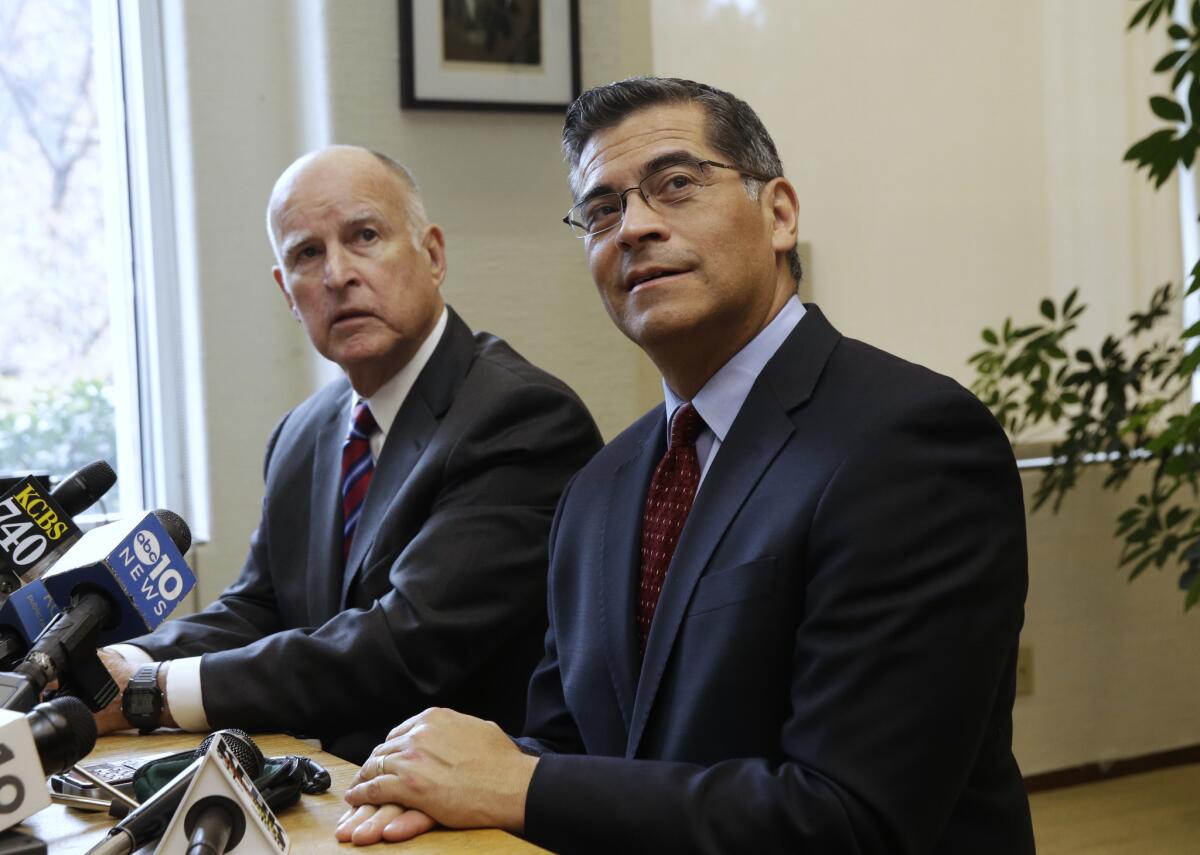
[0,460,116,596]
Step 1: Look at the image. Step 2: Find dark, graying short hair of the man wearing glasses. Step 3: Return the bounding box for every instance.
[563,77,804,283]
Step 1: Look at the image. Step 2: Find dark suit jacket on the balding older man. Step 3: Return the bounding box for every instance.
[131,311,600,761]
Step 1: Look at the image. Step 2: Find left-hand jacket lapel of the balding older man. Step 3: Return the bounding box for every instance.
[308,387,352,622]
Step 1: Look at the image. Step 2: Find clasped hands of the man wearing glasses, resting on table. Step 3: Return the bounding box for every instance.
[336,710,538,844]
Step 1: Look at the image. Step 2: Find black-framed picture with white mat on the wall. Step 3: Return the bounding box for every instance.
[400,0,580,113]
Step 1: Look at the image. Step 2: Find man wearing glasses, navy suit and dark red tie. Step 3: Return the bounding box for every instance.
[337,78,1033,855]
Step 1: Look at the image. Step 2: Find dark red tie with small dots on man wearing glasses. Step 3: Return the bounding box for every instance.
[637,403,704,653]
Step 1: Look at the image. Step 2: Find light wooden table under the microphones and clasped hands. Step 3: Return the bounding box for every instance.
[19,733,546,855]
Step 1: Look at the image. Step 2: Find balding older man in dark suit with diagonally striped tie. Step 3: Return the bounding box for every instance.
[91,147,599,760]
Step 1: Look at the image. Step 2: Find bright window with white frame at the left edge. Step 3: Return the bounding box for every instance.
[0,0,199,527]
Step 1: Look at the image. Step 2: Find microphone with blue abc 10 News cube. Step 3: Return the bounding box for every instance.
[0,510,196,711]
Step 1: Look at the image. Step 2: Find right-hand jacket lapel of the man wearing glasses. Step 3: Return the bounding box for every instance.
[625,306,840,758]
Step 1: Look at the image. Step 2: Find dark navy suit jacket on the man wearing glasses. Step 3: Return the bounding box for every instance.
[523,306,1033,855]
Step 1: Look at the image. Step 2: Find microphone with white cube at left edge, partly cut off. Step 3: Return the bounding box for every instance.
[0,696,96,829]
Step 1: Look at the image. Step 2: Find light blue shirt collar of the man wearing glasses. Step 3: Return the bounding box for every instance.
[662,295,804,442]
